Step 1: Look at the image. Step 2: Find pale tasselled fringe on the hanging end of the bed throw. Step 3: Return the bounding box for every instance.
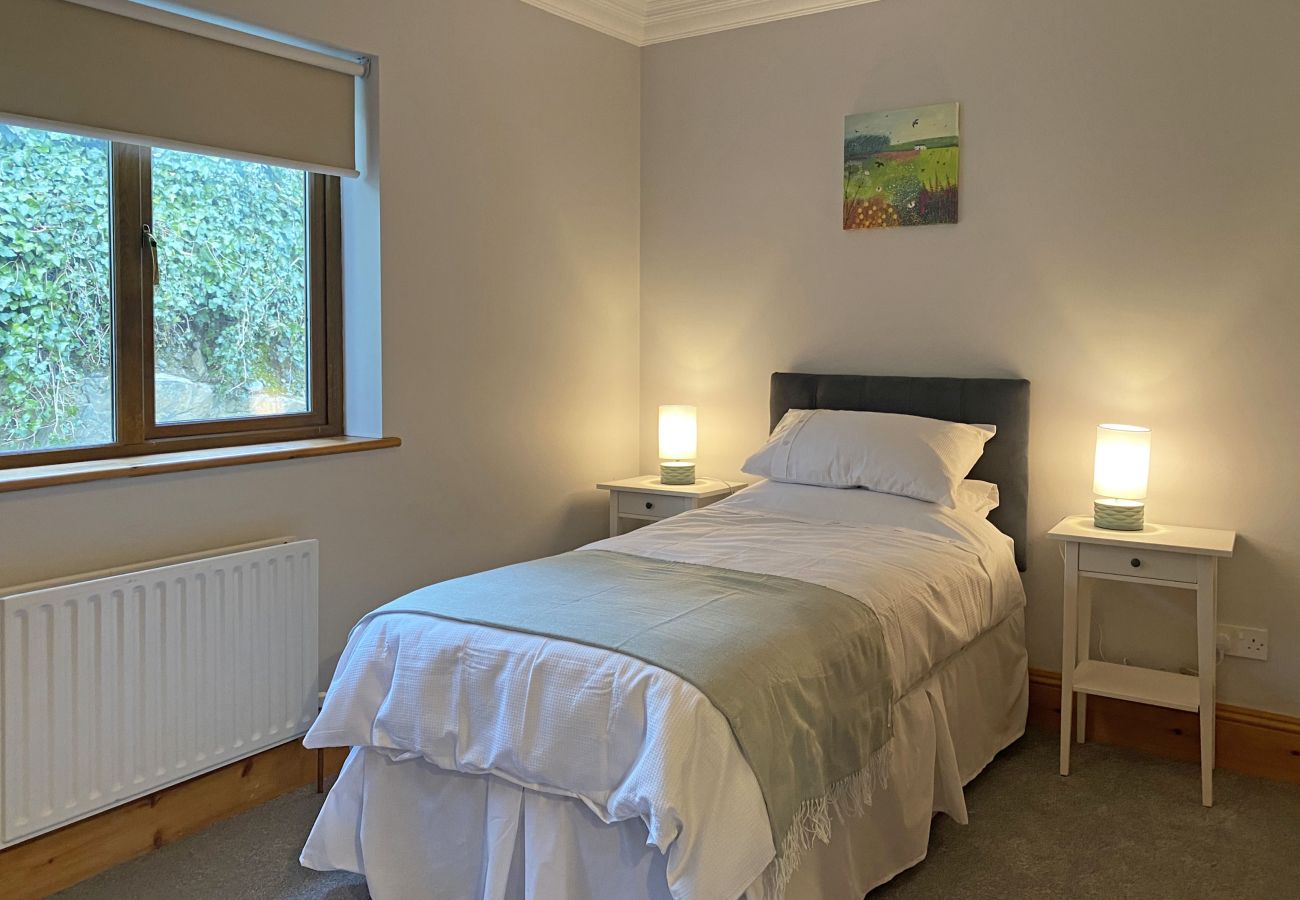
[763,740,893,900]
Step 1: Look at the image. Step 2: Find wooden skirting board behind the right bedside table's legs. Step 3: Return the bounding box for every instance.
[1030,668,1300,784]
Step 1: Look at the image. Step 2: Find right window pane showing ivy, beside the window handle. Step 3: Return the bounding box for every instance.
[153,150,309,424]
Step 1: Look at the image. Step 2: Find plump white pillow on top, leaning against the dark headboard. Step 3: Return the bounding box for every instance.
[741,410,993,509]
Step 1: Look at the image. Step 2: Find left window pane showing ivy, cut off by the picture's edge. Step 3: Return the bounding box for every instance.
[0,125,113,453]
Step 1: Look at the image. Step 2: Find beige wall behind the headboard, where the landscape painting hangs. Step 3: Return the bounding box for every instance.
[641,0,1300,714]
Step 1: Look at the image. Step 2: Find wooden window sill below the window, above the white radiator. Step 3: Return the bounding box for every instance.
[0,437,402,493]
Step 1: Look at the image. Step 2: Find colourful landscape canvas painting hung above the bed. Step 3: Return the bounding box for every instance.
[844,103,957,230]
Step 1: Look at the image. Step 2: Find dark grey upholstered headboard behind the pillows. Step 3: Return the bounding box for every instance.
[771,372,1030,572]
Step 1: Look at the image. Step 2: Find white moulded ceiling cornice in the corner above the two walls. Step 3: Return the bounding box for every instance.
[524,0,874,47]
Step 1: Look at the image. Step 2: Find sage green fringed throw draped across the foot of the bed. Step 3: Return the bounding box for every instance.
[385,550,893,891]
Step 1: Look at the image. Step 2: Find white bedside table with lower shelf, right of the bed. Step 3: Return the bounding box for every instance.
[1048,515,1236,806]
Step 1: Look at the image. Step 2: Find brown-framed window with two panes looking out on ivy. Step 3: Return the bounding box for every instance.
[0,125,342,468]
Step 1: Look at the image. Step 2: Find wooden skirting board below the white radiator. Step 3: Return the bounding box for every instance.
[0,741,347,900]
